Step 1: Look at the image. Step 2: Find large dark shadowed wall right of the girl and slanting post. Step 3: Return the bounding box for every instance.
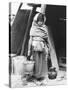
[46,5,66,57]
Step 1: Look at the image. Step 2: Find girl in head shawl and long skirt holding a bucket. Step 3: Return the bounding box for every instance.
[28,13,49,80]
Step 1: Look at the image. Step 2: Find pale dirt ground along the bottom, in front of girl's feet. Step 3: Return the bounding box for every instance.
[11,71,67,88]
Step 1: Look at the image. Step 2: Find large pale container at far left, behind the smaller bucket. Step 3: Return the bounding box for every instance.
[12,56,27,76]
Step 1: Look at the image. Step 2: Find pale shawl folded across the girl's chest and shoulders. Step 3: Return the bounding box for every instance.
[30,22,48,38]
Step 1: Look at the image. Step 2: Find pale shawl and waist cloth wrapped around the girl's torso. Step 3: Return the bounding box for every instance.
[30,21,48,51]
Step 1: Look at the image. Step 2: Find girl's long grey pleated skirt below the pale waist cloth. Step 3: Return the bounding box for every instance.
[33,51,48,78]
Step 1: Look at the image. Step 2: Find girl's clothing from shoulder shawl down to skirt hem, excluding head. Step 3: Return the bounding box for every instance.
[30,21,48,78]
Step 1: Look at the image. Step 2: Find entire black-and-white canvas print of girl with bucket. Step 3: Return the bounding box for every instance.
[8,2,67,88]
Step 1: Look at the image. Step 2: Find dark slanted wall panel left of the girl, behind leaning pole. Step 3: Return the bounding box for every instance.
[10,10,30,54]
